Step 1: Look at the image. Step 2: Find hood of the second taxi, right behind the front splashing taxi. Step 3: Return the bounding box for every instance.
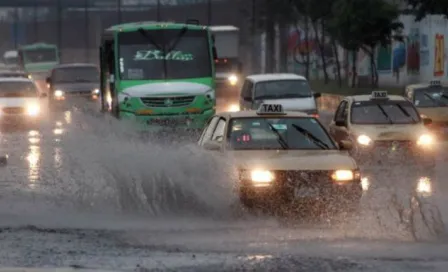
[351,124,429,141]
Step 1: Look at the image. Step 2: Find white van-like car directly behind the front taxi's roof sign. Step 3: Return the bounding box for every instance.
[239,74,321,117]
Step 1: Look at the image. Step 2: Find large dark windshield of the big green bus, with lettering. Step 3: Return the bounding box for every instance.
[118,29,212,80]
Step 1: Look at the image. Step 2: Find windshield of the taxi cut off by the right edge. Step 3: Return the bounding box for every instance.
[414,87,448,108]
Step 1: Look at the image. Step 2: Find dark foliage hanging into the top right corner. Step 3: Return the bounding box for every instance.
[405,0,448,21]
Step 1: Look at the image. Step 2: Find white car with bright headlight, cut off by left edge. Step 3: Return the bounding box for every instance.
[0,77,46,125]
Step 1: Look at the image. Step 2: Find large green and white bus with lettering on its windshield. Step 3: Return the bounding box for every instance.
[100,21,216,129]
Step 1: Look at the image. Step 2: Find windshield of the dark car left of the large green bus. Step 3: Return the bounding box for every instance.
[51,66,100,83]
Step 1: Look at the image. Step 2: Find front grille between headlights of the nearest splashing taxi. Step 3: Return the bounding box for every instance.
[274,170,332,186]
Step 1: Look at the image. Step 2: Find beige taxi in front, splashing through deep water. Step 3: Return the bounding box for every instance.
[198,104,363,214]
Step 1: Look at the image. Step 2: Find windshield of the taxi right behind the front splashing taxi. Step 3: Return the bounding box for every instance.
[350,100,420,125]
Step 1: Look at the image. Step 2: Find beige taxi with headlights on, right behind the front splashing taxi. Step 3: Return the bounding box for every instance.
[329,91,436,196]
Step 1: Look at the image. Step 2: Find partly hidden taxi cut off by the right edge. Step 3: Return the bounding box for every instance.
[405,80,448,139]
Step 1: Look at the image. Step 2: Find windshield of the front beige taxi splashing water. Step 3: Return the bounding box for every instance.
[227,117,336,150]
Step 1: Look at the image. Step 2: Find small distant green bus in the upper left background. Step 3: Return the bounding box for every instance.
[18,43,60,75]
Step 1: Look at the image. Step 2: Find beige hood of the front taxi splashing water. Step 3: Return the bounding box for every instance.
[228,150,357,170]
